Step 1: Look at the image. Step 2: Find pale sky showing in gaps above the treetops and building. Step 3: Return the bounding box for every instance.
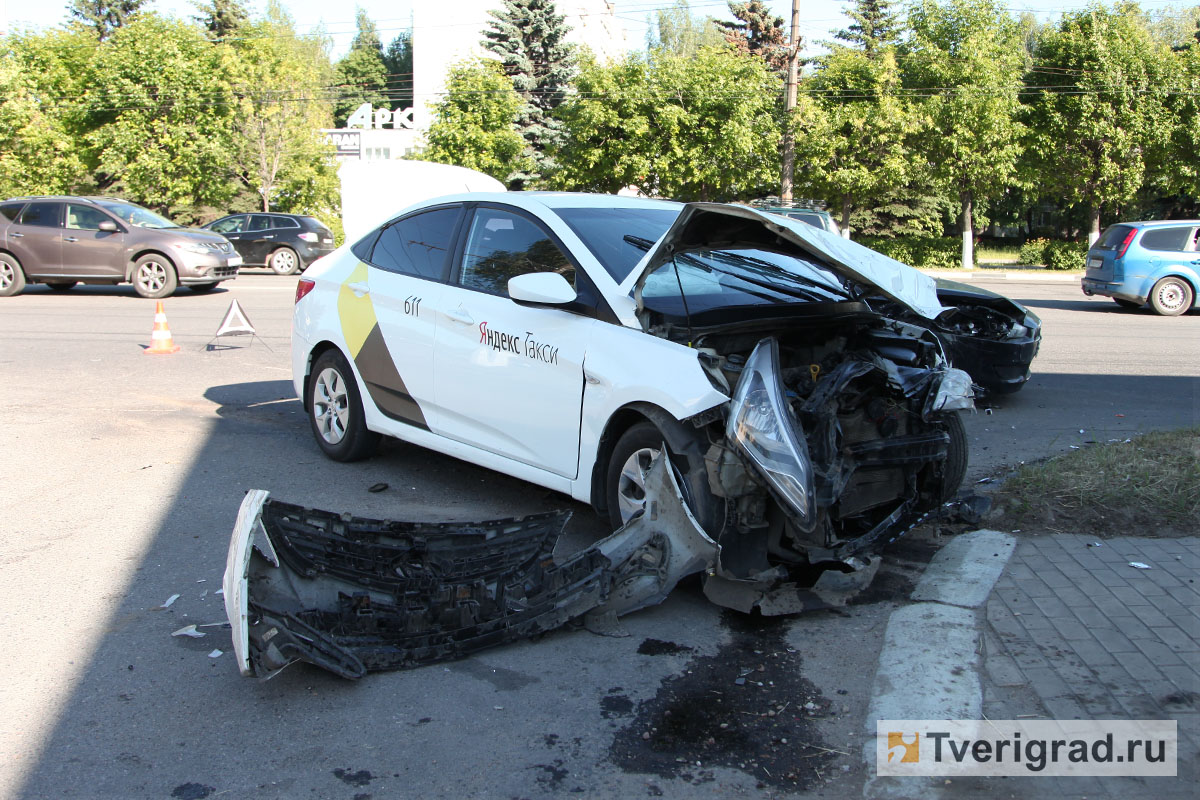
[0,0,1194,58]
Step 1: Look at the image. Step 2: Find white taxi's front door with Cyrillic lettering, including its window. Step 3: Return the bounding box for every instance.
[434,206,604,479]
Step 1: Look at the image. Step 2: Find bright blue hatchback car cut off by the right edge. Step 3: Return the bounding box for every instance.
[1084,219,1200,317]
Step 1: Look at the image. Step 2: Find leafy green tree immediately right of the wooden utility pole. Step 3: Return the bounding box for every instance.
[792,47,924,236]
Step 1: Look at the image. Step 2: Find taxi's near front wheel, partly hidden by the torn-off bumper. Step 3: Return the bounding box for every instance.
[605,422,725,539]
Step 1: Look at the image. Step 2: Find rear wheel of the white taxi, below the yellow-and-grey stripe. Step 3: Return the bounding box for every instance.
[305,350,379,461]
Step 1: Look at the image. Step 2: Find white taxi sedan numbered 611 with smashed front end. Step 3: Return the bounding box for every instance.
[292,192,972,607]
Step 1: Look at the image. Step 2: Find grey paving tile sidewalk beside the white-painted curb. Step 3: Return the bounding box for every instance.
[982,534,1200,800]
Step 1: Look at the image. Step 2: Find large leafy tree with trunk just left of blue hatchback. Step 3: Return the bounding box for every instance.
[1026,5,1171,241]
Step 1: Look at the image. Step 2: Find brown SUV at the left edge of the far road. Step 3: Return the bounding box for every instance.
[0,196,241,299]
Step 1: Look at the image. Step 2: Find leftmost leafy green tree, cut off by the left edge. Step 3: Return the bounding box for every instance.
[0,29,97,197]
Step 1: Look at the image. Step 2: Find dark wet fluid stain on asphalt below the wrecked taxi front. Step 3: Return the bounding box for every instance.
[601,612,833,789]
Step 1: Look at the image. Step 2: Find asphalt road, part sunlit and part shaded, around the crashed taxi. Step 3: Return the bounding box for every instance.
[0,275,1200,800]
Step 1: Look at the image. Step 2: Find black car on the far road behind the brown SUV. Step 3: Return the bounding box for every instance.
[204,213,334,275]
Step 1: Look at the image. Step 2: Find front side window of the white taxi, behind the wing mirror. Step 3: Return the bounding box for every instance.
[458,209,575,296]
